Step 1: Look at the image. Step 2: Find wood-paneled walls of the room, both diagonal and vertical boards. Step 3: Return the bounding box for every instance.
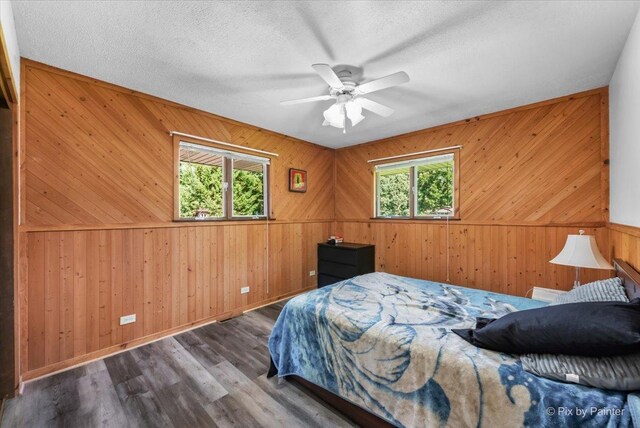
[17,60,640,379]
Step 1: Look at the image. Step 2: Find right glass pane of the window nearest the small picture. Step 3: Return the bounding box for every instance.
[233,159,265,217]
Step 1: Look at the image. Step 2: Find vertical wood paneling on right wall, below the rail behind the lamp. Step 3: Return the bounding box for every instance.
[337,221,611,296]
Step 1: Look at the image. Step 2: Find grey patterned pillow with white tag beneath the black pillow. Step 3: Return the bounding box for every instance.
[520,354,640,391]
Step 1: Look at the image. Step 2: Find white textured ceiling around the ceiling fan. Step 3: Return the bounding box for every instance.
[13,0,640,147]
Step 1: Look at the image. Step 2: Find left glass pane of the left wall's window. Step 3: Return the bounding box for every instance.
[180,156,224,218]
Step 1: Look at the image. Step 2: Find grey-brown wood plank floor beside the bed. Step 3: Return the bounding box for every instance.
[1,303,353,428]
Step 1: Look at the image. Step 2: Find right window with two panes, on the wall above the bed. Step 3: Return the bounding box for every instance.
[375,153,457,218]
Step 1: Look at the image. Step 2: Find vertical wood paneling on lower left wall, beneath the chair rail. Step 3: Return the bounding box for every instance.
[25,222,332,377]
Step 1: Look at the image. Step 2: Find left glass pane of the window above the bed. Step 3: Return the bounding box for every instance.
[378,168,410,217]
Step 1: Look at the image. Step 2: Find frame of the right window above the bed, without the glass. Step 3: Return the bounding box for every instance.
[372,149,460,221]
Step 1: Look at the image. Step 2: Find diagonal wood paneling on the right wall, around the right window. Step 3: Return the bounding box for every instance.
[336,90,606,225]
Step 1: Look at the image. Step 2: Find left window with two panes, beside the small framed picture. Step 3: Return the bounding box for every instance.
[176,141,269,220]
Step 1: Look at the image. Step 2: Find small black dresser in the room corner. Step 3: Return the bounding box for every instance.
[318,242,376,287]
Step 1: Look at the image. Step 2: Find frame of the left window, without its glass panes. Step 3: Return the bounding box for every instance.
[173,135,273,222]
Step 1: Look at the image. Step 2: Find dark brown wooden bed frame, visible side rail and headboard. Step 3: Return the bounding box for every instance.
[276,259,640,427]
